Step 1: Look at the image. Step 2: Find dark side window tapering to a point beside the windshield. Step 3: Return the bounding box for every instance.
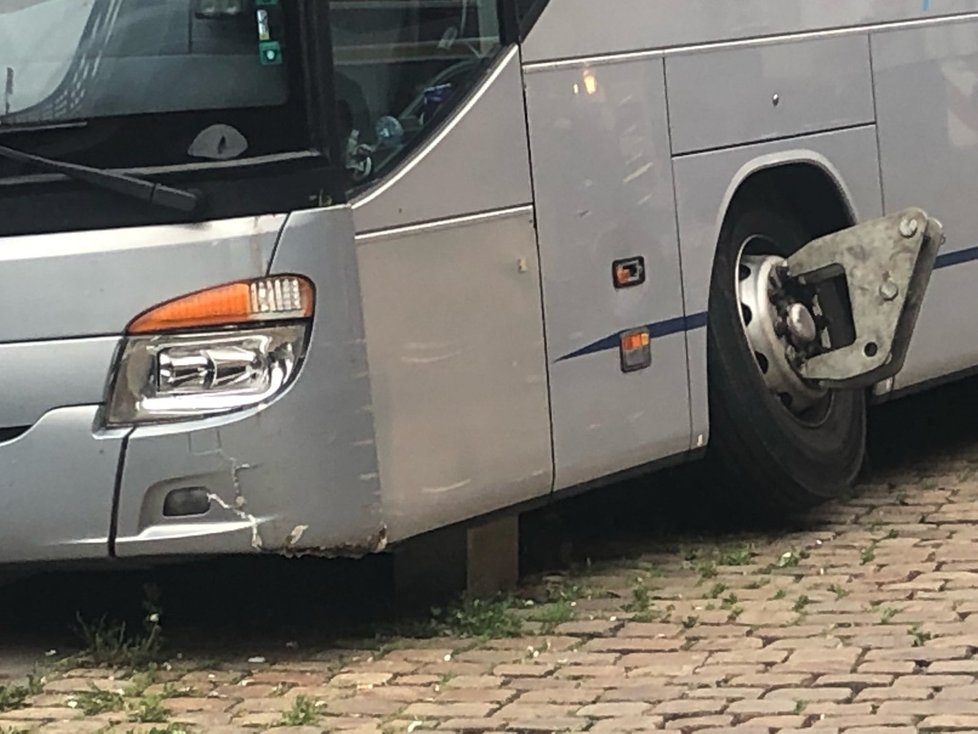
[330,0,501,188]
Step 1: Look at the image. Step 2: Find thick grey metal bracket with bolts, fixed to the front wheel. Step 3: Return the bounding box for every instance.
[785,208,944,389]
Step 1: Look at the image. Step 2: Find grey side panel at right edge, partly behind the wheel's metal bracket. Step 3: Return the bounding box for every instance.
[872,21,978,389]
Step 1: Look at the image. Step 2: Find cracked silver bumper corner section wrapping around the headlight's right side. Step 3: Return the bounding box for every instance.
[115,209,385,557]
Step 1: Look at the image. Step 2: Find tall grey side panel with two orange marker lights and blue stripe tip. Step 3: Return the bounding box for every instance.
[526,58,689,489]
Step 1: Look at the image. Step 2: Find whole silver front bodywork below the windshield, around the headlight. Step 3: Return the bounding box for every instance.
[0,207,387,563]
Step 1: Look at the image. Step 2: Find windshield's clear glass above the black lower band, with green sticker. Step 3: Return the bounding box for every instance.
[0,0,289,125]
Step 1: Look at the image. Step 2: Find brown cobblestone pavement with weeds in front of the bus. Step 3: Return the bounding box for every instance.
[0,388,978,734]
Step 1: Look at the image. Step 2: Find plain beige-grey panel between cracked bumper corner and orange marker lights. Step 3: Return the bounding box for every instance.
[358,206,553,541]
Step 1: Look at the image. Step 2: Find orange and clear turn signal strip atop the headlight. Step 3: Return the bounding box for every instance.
[128,275,314,334]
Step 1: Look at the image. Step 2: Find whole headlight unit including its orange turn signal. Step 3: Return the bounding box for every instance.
[106,276,313,426]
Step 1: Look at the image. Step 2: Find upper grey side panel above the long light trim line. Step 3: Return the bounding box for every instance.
[524,0,978,62]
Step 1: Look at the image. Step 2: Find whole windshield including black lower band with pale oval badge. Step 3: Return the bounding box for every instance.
[0,0,308,171]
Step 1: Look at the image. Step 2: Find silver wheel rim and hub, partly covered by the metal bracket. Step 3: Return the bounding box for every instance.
[736,255,827,414]
